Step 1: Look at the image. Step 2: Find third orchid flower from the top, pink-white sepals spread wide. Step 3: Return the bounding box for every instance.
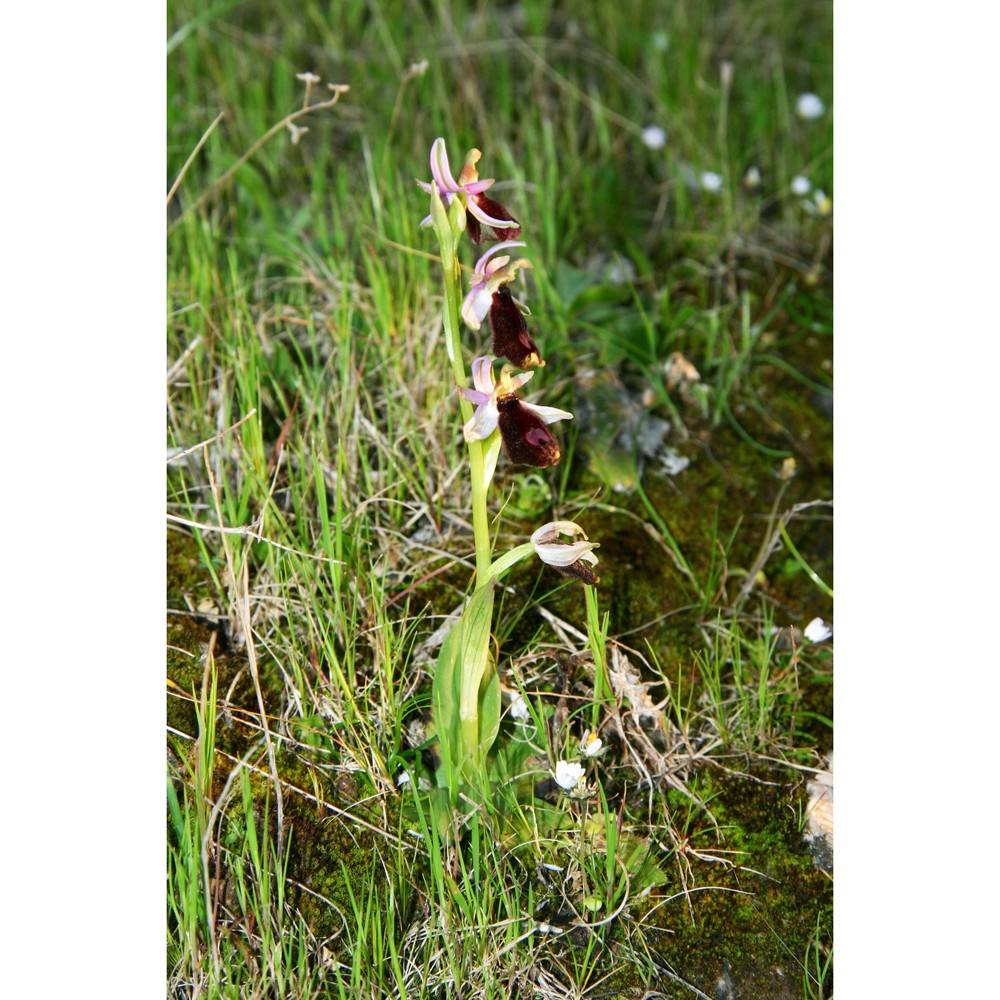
[459,356,573,469]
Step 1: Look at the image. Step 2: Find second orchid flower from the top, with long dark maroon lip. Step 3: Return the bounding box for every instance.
[462,240,545,368]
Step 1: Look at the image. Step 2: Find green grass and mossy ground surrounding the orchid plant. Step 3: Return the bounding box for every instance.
[167,0,833,998]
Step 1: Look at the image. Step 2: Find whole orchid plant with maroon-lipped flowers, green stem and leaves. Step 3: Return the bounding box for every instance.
[417,138,598,805]
